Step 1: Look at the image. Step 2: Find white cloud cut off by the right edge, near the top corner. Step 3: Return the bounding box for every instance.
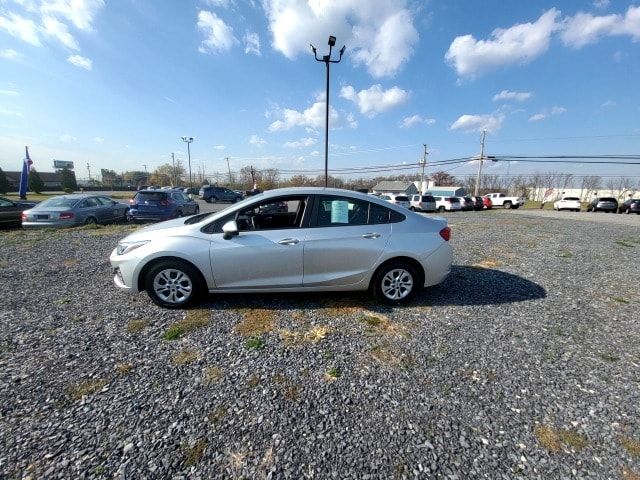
[560,6,640,48]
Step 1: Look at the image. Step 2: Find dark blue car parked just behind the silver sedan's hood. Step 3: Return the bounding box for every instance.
[129,190,200,221]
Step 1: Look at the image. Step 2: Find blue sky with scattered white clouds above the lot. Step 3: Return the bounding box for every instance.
[0,0,640,182]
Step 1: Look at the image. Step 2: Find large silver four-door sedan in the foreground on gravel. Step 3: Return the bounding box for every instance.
[110,188,452,308]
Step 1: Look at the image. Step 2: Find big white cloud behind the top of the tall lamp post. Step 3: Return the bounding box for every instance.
[263,0,418,77]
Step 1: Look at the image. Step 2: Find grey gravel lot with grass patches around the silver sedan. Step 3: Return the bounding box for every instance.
[0,210,640,479]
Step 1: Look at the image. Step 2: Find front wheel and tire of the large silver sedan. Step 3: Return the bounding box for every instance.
[144,259,204,308]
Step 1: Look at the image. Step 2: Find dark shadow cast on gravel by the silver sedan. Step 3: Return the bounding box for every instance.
[196,266,547,312]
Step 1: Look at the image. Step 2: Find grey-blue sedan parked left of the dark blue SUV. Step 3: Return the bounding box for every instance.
[22,192,129,228]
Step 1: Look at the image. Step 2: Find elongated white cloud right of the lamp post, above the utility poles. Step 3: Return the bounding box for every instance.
[445,8,560,77]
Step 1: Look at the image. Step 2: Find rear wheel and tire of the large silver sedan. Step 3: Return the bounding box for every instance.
[371,260,422,305]
